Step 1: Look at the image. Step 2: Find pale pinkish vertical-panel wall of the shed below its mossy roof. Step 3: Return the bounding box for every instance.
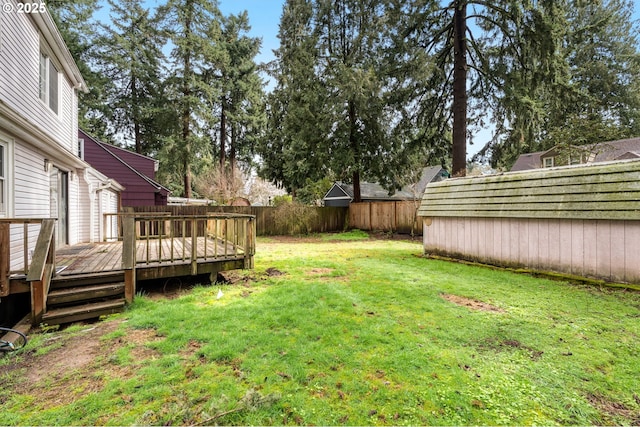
[423,218,640,283]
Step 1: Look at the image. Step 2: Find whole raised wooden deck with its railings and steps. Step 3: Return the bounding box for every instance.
[0,213,255,324]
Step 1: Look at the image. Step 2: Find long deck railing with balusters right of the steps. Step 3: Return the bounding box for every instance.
[120,213,256,301]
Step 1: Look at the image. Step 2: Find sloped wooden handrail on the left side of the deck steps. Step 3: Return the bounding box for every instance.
[27,219,56,324]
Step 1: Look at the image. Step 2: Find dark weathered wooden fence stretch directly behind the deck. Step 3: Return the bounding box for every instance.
[133,206,348,236]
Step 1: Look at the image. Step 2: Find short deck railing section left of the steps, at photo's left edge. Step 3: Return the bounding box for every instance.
[0,218,48,297]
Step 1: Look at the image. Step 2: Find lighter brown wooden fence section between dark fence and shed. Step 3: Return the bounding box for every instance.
[349,200,422,235]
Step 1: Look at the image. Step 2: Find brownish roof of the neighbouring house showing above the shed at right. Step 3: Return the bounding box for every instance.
[511,137,640,172]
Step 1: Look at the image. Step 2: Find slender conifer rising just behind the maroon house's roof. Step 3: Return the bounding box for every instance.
[99,0,167,155]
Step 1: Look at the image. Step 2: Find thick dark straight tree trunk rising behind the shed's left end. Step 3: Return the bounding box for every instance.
[451,0,467,176]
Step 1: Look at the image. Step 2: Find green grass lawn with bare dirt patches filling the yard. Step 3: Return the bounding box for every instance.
[0,233,640,425]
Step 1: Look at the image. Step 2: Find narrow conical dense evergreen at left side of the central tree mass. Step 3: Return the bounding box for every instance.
[258,0,329,194]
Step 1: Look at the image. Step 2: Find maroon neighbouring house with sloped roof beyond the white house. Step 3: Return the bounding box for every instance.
[78,129,170,206]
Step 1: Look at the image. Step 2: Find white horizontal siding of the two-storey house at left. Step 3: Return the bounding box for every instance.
[0,0,101,270]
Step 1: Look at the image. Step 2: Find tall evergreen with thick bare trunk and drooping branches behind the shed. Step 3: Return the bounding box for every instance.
[407,0,562,176]
